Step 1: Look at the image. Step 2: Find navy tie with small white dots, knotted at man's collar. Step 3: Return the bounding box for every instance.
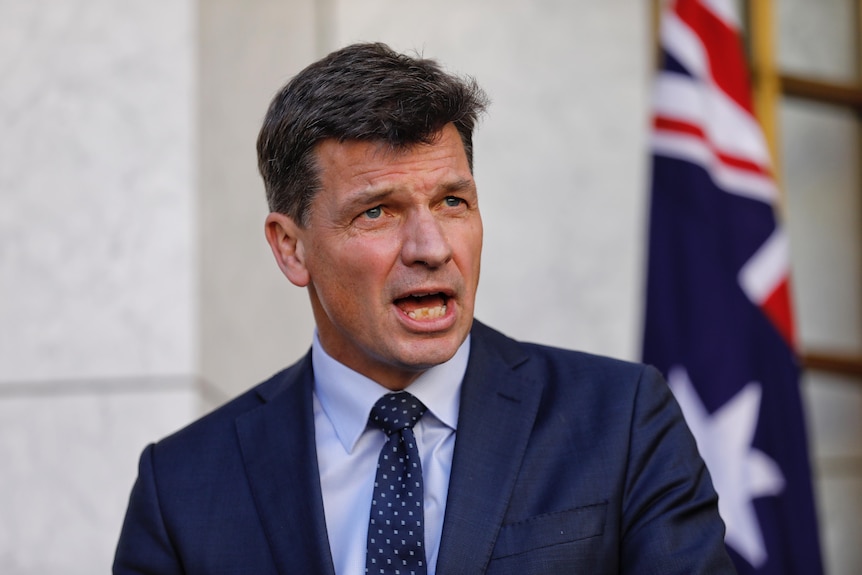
[365,391,426,575]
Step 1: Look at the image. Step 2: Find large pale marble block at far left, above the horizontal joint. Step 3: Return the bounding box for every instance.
[0,0,195,381]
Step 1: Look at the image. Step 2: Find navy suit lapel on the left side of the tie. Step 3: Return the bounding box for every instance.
[236,354,335,575]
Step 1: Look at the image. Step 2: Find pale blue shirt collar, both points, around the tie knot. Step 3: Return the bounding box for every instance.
[311,330,470,453]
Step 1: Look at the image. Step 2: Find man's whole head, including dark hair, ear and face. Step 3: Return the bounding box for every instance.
[258,44,486,389]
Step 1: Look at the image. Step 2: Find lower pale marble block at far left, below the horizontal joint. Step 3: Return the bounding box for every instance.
[0,378,199,575]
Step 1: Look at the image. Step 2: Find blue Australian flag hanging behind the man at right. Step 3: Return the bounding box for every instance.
[643,0,822,575]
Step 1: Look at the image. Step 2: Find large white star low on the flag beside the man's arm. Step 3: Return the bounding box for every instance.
[668,366,784,568]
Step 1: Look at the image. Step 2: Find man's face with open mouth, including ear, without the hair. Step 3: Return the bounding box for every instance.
[267,124,482,389]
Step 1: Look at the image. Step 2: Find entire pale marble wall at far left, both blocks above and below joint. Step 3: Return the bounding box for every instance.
[0,0,200,575]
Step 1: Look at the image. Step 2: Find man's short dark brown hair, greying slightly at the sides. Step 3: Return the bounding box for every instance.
[257,43,488,226]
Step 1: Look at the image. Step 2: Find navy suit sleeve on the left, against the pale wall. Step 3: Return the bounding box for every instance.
[113,445,183,575]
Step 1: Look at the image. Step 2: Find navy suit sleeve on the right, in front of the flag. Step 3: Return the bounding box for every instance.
[620,367,736,575]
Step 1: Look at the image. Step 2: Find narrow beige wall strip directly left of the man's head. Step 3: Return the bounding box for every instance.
[198,0,317,396]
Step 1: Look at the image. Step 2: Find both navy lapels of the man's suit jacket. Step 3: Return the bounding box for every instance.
[236,321,543,575]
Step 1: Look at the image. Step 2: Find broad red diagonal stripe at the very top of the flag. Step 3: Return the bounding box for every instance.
[675,0,753,113]
